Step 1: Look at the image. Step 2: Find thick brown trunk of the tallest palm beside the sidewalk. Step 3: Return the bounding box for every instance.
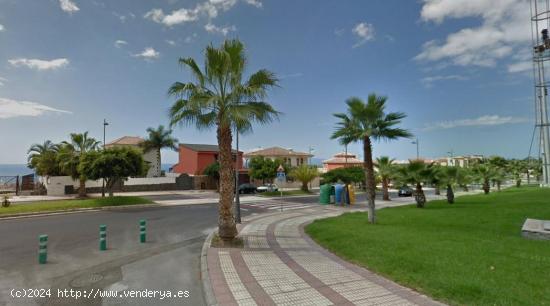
[218,125,237,242]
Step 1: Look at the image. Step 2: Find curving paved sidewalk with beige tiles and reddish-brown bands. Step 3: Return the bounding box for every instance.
[207,203,442,305]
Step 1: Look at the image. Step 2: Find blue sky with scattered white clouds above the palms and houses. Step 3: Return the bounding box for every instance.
[0,0,538,163]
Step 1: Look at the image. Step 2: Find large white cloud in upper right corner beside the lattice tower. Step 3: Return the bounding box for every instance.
[415,0,531,67]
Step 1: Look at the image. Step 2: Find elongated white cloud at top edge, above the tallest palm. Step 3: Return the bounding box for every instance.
[143,0,262,27]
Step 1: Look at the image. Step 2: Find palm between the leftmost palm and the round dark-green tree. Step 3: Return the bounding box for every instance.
[59,132,101,198]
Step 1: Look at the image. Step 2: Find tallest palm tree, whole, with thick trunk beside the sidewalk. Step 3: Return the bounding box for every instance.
[168,40,279,242]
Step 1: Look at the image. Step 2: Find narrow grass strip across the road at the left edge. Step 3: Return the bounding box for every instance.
[0,197,153,215]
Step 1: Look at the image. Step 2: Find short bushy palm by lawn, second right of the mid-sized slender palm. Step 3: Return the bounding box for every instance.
[398,160,431,208]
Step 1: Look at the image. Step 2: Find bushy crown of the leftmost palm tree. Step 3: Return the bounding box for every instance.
[27,140,61,177]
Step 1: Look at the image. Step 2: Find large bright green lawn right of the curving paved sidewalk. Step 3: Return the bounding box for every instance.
[306,187,550,305]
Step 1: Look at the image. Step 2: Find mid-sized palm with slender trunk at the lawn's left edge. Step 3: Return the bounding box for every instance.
[331,93,412,223]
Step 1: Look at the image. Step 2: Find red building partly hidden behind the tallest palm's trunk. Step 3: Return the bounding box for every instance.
[172,143,243,175]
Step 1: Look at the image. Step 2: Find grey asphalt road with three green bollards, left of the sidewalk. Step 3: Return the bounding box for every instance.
[0,204,264,305]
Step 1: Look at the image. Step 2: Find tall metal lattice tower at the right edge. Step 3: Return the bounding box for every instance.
[530,0,550,187]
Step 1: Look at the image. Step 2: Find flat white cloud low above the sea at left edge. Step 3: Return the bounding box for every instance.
[0,98,72,119]
